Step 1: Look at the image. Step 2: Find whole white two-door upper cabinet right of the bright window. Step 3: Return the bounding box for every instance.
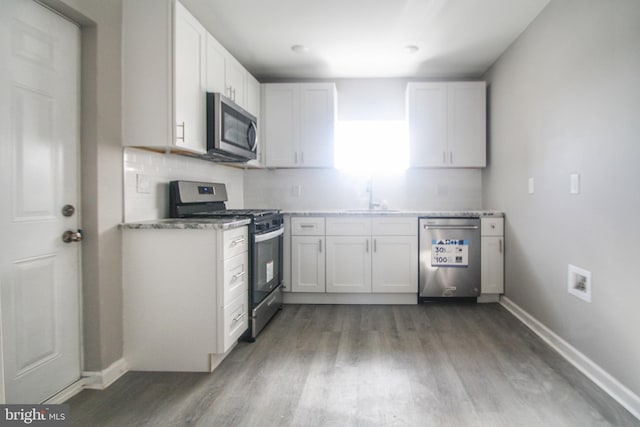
[407,82,487,168]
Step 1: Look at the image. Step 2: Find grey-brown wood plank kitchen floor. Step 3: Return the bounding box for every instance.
[68,303,640,427]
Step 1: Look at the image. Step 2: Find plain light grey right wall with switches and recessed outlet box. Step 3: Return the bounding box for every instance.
[483,0,640,402]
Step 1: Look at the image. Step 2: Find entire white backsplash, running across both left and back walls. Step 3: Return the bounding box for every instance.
[124,148,482,222]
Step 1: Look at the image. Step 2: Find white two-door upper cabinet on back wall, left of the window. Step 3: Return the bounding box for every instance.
[262,83,336,167]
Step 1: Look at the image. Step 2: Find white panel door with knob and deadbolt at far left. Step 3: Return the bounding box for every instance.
[0,0,80,403]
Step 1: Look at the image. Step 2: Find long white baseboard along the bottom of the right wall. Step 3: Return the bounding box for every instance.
[500,297,640,419]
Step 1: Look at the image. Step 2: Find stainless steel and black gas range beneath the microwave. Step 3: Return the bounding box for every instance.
[169,181,284,341]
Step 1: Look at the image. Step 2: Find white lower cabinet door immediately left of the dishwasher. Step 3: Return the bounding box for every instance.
[371,236,418,294]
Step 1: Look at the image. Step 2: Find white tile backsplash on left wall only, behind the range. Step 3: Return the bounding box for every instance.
[124,148,244,222]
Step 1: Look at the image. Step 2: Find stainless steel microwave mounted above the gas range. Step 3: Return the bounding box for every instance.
[206,92,258,162]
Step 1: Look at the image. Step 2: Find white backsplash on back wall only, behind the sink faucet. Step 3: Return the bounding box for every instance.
[244,169,482,210]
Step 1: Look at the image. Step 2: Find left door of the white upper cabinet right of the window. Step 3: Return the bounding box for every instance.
[407,83,449,167]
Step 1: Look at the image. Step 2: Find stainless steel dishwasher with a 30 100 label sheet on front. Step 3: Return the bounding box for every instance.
[418,217,480,302]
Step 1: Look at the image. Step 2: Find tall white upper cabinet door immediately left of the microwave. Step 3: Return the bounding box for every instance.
[175,3,207,153]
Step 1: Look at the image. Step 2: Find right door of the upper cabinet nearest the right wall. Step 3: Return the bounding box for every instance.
[447,82,487,167]
